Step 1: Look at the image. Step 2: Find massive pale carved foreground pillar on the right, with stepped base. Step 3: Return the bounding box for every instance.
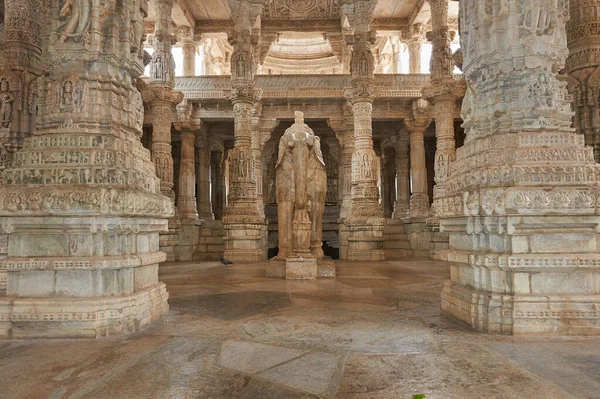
[435,0,600,335]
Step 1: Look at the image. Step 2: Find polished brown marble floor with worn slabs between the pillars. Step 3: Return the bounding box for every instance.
[0,260,600,399]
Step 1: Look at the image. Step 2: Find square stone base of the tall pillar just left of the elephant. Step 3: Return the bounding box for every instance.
[223,222,267,263]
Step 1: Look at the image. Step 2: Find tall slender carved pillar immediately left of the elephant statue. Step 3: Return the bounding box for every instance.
[223,0,266,262]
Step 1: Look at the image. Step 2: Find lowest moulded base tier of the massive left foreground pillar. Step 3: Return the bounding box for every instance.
[0,283,169,339]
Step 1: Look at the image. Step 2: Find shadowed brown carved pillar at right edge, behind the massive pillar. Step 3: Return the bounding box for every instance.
[565,0,600,162]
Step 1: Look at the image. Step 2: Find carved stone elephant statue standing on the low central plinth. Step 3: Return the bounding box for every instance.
[275,111,327,260]
